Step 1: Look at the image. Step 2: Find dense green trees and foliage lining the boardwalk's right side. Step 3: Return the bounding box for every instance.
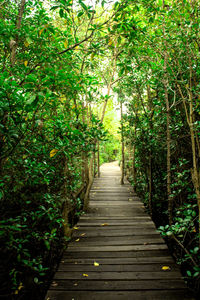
[117,1,200,287]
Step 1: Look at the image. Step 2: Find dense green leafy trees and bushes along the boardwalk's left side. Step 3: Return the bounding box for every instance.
[0,1,110,294]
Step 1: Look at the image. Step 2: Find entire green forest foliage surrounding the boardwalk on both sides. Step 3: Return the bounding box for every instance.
[0,0,200,299]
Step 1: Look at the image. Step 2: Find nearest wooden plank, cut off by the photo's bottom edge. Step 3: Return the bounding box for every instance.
[46,290,195,300]
